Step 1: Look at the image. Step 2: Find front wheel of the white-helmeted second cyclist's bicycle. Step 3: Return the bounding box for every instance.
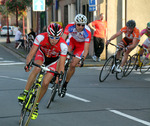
[47,83,58,108]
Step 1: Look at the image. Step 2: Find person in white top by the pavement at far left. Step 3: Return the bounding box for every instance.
[15,27,24,49]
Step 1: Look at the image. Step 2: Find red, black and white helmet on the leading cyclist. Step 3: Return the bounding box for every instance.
[47,23,63,37]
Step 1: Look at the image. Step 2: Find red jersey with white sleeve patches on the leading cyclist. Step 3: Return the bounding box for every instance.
[33,32,68,58]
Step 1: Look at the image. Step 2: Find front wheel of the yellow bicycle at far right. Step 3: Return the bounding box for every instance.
[124,54,138,77]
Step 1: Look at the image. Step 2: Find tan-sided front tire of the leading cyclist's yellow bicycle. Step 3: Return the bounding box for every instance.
[25,85,41,126]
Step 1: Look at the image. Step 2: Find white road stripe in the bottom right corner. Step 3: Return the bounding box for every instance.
[109,109,150,126]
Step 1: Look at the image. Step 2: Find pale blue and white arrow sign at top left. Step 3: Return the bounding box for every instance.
[33,0,45,11]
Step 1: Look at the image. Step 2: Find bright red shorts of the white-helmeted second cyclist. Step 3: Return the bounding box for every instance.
[66,37,85,59]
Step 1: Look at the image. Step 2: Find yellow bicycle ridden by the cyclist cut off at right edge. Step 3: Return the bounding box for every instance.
[127,45,150,75]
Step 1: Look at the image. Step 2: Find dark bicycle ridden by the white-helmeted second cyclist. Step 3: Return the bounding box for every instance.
[47,52,75,108]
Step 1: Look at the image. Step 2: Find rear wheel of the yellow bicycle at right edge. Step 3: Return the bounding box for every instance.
[140,58,150,74]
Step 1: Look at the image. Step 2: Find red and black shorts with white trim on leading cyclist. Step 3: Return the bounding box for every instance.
[35,49,59,76]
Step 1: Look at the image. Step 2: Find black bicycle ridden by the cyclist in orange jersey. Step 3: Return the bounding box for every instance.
[99,43,130,82]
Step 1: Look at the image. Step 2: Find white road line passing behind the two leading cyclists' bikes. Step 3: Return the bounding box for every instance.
[0,76,91,102]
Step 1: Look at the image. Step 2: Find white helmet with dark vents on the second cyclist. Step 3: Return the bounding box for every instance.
[74,14,87,24]
